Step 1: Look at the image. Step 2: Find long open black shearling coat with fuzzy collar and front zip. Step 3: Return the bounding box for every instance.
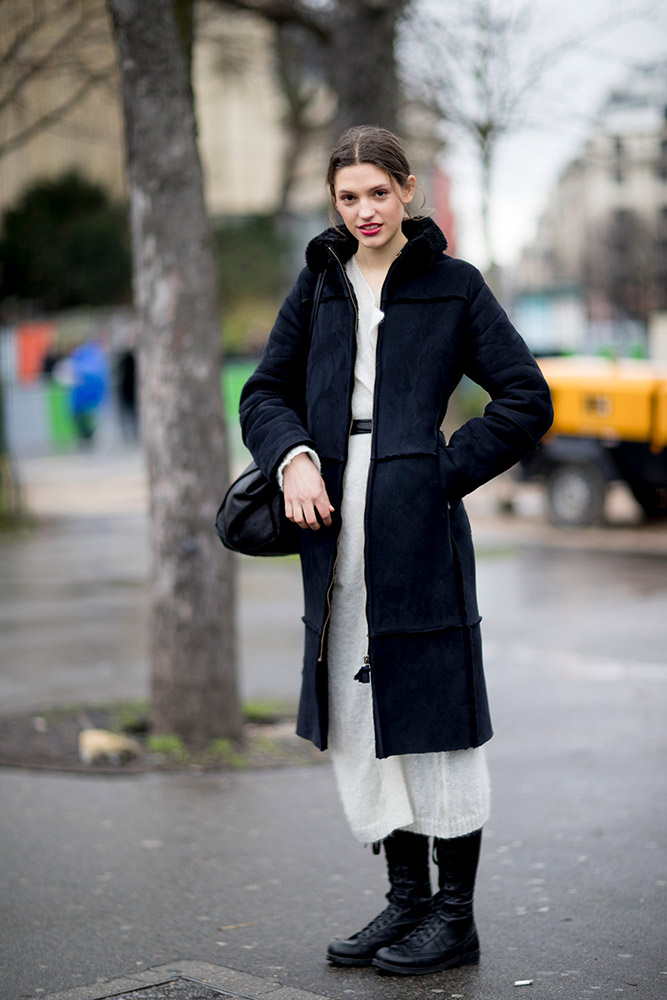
[241,219,553,757]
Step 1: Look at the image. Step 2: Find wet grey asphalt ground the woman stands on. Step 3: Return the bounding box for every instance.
[0,454,667,1000]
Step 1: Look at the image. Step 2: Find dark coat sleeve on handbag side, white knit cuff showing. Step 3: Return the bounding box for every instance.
[240,268,315,479]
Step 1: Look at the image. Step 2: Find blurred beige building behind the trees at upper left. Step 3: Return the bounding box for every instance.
[0,0,332,216]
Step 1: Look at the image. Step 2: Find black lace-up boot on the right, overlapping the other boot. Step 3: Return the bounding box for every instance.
[373,830,482,976]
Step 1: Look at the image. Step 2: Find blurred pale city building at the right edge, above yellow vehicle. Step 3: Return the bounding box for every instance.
[516,61,667,353]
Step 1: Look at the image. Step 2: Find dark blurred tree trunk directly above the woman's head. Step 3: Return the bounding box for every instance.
[330,0,406,139]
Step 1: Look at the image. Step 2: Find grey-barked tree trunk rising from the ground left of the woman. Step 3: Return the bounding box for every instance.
[107,0,242,749]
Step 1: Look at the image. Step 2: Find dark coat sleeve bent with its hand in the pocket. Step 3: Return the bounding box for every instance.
[444,269,553,498]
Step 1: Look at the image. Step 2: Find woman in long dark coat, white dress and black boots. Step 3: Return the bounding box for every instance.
[241,126,552,974]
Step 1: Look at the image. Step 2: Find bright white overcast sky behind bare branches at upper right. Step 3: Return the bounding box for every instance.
[438,0,667,268]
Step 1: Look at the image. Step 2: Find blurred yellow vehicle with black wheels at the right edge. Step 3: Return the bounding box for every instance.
[519,357,667,527]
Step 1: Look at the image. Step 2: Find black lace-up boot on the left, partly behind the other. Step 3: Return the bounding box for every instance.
[327,830,431,965]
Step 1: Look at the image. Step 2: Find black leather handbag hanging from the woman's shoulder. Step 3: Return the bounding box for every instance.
[215,271,324,556]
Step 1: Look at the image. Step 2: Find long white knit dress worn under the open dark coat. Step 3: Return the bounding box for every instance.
[327,257,490,842]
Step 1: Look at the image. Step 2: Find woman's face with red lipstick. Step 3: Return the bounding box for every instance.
[334,163,415,252]
